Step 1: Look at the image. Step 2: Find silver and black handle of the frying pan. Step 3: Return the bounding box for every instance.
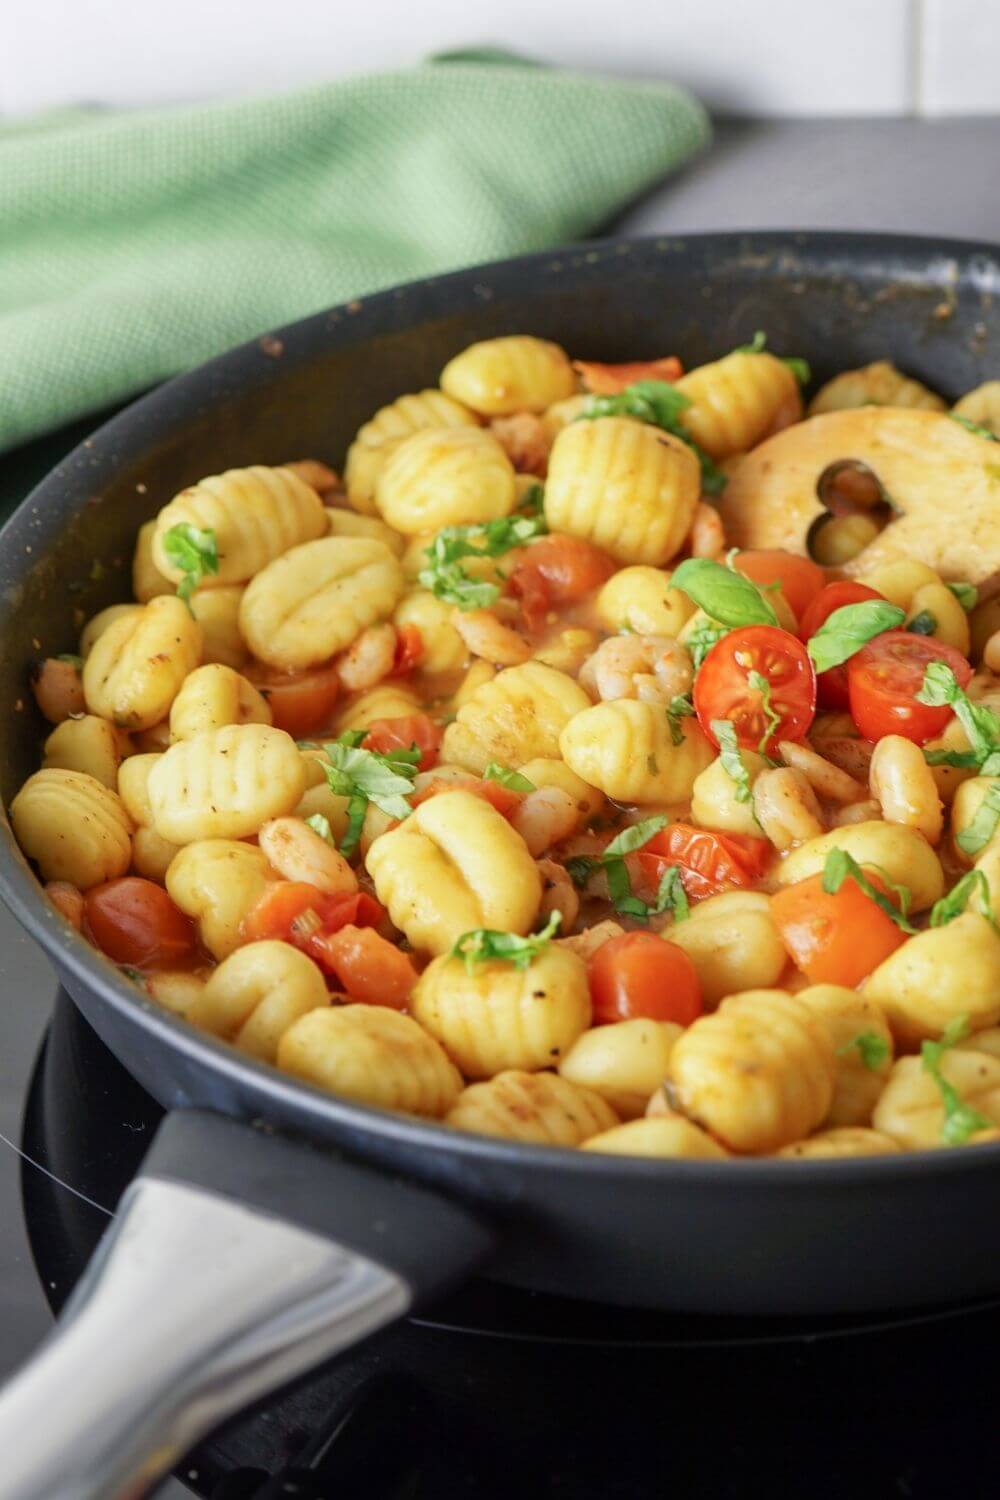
[0,1110,490,1500]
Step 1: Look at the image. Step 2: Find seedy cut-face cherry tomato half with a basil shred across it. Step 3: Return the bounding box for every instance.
[694,626,816,755]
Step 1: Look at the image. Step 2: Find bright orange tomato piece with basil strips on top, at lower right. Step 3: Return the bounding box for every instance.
[771,872,906,990]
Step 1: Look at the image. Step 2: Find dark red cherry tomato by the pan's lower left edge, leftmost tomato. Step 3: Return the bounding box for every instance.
[84,875,196,969]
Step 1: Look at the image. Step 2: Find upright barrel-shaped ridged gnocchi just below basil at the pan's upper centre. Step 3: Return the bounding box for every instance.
[544,417,702,567]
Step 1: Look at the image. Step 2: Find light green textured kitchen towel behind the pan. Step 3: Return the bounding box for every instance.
[0,54,709,452]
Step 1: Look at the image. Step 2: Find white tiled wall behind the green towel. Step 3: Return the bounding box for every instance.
[0,0,1000,118]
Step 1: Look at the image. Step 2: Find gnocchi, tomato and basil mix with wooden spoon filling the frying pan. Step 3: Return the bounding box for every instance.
[10,335,1000,1172]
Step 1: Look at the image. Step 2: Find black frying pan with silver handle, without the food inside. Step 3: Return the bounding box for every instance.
[0,234,1000,1500]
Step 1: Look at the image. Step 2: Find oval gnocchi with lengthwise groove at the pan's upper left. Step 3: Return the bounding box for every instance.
[240,537,405,672]
